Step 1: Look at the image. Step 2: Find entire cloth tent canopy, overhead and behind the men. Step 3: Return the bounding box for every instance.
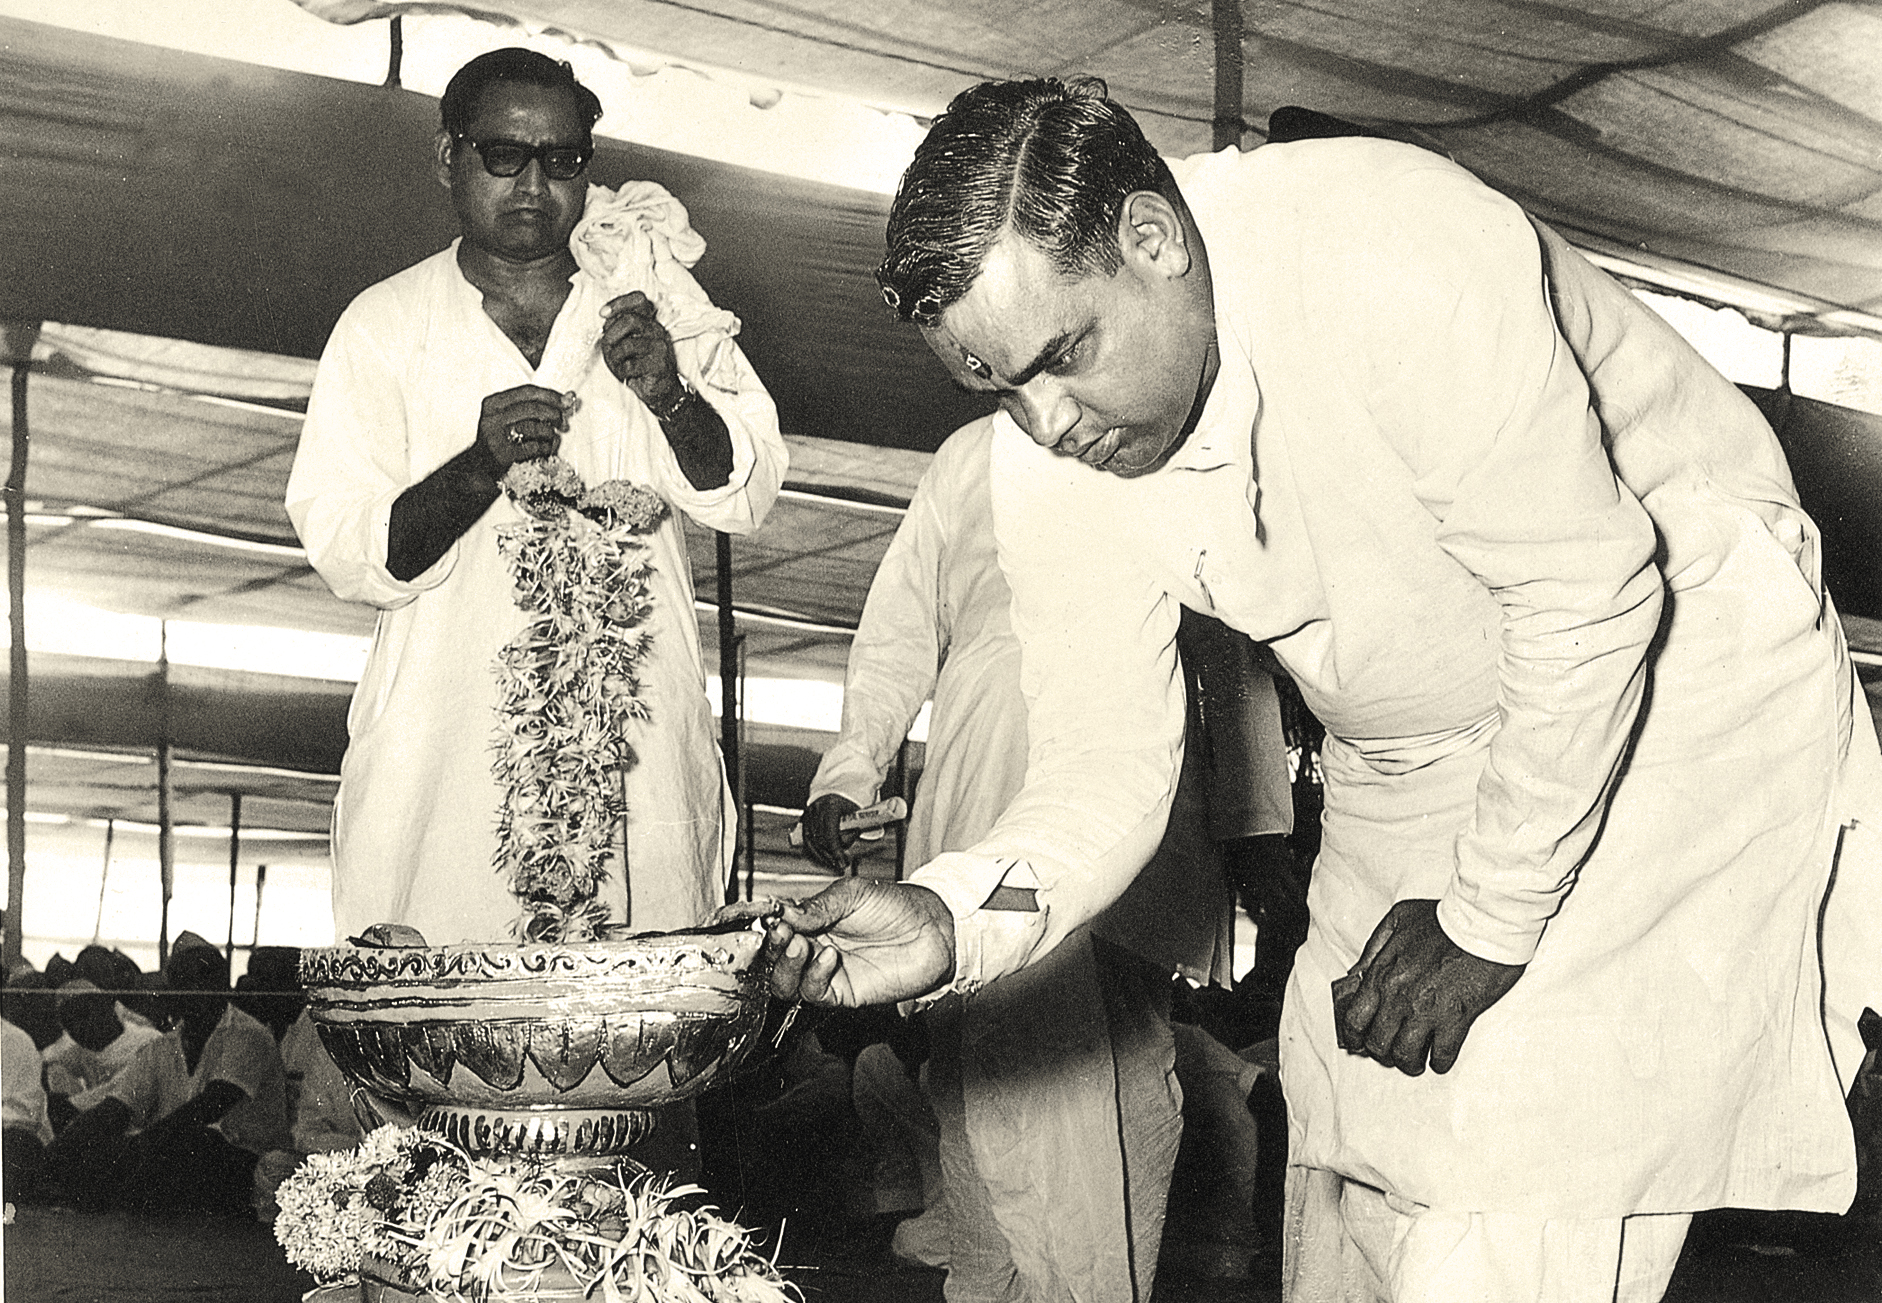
[0,0,1882,839]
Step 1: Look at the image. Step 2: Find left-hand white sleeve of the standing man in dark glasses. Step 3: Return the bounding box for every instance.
[286,303,462,608]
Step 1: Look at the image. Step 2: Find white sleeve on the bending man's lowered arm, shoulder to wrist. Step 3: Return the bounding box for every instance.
[1316,162,1662,964]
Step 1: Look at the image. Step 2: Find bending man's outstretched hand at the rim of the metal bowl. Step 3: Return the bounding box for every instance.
[715,877,954,1007]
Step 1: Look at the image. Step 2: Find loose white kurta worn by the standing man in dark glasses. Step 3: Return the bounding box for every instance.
[288,245,787,945]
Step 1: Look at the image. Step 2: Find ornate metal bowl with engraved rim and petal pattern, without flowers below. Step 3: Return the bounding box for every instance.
[301,925,768,1156]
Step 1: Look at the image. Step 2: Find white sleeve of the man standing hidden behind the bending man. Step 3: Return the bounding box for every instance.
[811,459,960,806]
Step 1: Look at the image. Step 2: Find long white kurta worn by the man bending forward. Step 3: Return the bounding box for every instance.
[915,139,1882,1216]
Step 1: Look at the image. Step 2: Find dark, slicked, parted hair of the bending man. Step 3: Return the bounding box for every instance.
[875,77,1176,326]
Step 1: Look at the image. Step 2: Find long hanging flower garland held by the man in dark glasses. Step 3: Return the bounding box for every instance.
[491,458,666,943]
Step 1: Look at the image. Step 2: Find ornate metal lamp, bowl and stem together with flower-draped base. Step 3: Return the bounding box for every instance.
[282,923,789,1303]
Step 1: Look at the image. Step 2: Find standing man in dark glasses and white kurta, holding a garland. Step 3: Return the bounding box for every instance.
[288,51,787,945]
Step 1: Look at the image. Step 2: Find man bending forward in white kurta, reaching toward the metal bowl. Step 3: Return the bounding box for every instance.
[749,83,1882,1303]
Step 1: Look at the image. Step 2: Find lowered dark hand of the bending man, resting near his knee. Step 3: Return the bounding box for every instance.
[1332,900,1523,1077]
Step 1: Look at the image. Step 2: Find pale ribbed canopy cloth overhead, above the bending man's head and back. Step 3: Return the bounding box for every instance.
[297,0,1882,333]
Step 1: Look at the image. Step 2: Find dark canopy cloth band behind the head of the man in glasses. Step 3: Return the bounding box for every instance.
[0,19,984,450]
